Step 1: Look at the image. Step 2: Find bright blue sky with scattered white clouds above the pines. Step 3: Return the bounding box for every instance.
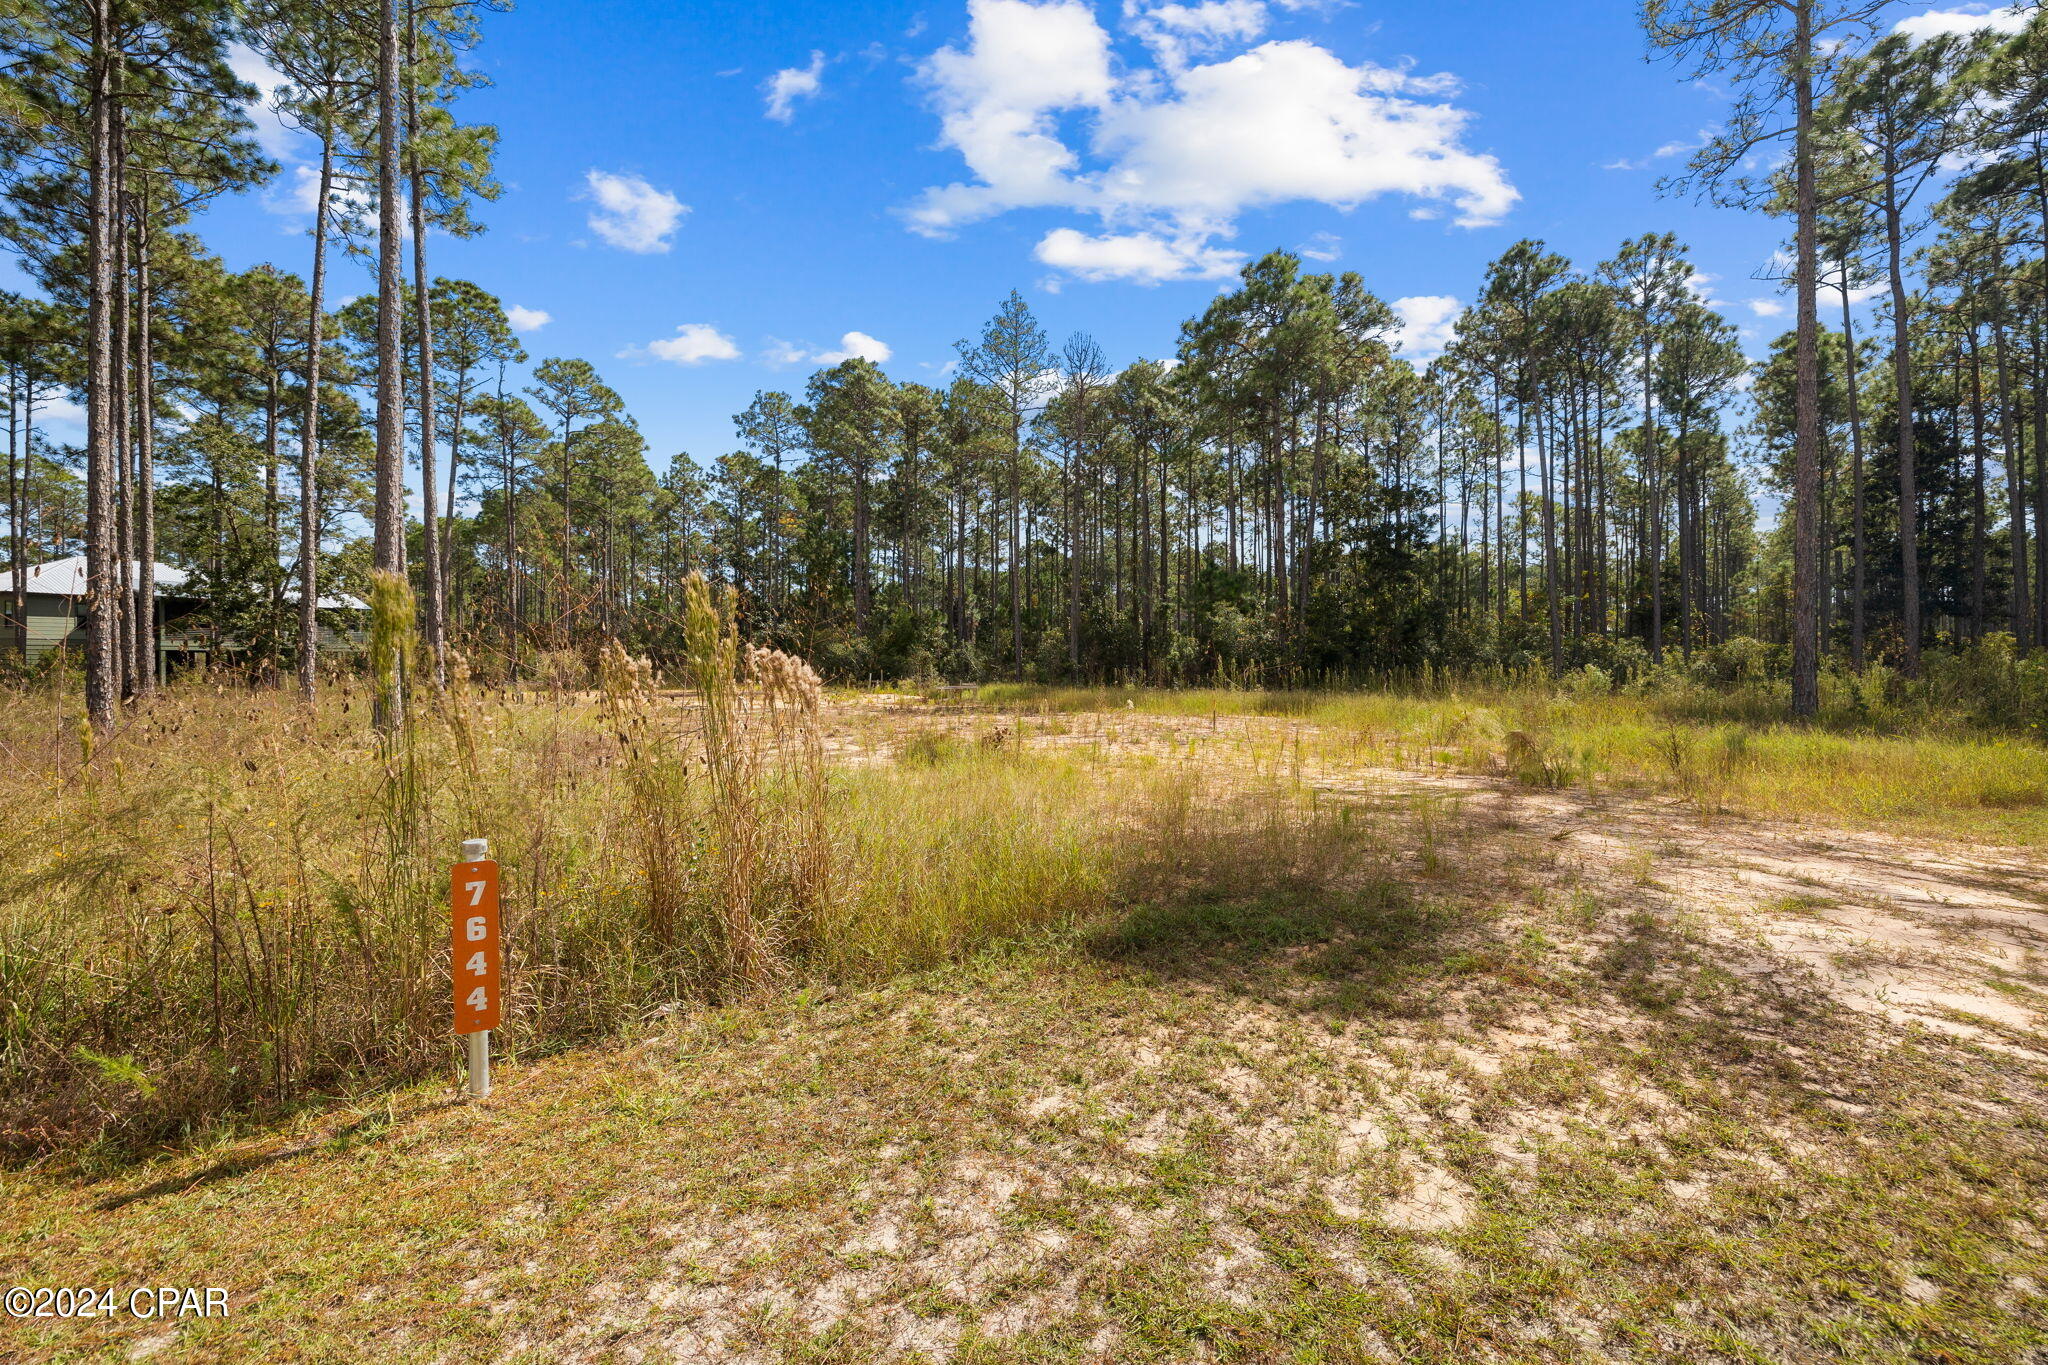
[12,0,2031,469]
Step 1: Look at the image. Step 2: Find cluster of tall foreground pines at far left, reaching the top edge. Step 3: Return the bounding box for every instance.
[0,0,502,724]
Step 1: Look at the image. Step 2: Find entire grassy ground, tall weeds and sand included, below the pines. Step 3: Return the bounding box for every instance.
[0,669,2048,1365]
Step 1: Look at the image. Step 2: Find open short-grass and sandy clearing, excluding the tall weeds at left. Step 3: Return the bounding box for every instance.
[0,698,2048,1365]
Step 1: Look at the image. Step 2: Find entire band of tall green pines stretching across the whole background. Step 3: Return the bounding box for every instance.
[0,0,2048,720]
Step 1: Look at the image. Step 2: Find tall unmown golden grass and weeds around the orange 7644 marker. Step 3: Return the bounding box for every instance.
[0,581,1376,1158]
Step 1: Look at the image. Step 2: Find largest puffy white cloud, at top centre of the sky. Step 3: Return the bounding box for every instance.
[905,0,1520,278]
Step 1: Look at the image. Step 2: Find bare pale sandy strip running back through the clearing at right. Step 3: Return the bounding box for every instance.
[836,696,2048,1058]
